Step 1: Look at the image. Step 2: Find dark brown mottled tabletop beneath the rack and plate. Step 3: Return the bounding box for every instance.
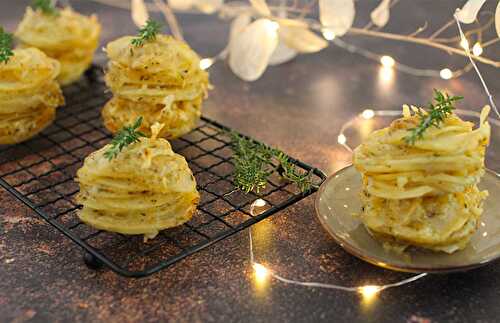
[0,0,500,322]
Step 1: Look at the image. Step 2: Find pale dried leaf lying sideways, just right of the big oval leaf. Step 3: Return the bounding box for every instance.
[280,27,328,53]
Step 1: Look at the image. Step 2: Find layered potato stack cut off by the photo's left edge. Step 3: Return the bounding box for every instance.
[0,48,64,144]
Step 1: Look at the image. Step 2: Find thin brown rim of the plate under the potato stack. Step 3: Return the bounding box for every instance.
[314,163,500,273]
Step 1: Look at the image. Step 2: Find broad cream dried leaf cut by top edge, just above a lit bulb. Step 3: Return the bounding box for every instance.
[319,0,356,36]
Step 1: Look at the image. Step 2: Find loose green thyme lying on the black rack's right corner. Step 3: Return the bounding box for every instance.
[230,132,314,193]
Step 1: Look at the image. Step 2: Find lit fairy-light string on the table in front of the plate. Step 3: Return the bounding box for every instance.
[248,199,428,296]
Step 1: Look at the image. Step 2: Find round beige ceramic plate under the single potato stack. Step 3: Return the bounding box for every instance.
[316,166,500,272]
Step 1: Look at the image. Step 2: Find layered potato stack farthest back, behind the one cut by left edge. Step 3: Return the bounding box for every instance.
[15,7,101,85]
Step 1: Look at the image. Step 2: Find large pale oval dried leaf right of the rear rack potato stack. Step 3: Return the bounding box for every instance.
[229,19,278,81]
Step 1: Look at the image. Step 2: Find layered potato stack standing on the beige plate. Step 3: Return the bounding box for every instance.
[354,107,491,253]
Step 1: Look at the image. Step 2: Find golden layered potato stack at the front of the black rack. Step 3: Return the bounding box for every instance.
[77,127,200,239]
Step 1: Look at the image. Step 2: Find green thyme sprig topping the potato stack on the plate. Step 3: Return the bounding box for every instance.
[404,89,463,145]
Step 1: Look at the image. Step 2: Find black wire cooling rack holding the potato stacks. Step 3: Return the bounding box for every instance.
[0,67,325,277]
